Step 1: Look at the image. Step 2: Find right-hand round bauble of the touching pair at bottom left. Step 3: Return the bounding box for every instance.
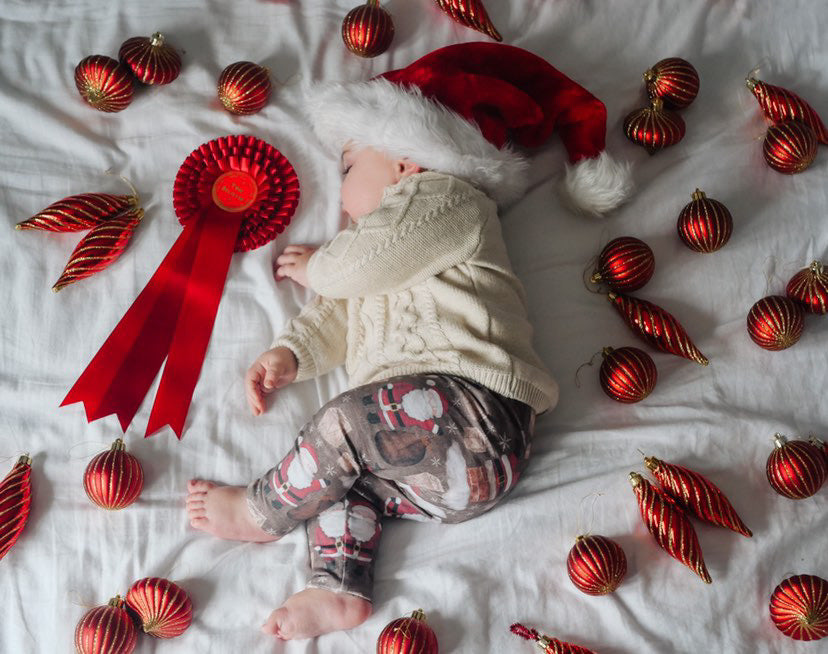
[124,577,193,638]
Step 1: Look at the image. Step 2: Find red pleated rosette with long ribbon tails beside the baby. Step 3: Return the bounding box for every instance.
[61,135,299,438]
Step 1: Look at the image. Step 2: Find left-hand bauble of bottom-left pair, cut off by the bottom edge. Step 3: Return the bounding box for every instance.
[75,595,138,654]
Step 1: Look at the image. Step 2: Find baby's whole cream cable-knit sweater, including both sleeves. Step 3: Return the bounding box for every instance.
[273,172,558,413]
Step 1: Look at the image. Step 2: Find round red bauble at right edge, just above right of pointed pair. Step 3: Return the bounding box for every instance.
[765,434,828,500]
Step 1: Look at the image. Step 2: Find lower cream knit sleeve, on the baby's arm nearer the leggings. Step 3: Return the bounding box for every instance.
[273,295,348,381]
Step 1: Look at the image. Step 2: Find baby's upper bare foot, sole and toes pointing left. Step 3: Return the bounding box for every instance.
[187,479,278,543]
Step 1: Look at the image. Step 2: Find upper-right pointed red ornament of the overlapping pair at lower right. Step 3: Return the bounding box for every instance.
[644,456,753,538]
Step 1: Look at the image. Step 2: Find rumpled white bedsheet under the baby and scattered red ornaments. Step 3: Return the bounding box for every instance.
[0,0,828,654]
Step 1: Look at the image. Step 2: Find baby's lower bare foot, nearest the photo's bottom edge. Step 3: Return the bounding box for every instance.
[262,588,371,640]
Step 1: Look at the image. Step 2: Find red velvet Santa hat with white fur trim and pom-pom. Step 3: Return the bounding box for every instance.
[308,43,632,215]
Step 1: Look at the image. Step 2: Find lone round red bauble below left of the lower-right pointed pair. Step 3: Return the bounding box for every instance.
[566,536,627,595]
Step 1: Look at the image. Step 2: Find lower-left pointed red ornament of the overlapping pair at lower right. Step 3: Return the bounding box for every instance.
[630,472,713,584]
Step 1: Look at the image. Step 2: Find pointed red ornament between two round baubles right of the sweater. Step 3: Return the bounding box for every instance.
[607,292,709,366]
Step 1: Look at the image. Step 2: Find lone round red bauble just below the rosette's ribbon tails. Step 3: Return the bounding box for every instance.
[83,438,144,510]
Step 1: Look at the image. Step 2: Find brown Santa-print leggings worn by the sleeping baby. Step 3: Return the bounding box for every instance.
[247,374,535,601]
